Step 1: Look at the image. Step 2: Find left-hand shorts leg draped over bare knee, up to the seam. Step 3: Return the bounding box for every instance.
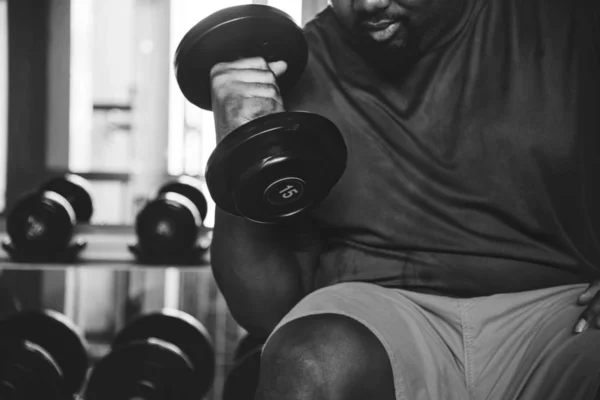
[265,283,468,400]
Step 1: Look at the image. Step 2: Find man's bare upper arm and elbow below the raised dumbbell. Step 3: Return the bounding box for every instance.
[211,209,317,336]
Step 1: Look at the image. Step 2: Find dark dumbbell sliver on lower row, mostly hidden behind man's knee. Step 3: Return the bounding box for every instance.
[223,335,264,400]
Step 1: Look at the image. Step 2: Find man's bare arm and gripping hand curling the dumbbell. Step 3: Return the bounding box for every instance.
[211,58,321,336]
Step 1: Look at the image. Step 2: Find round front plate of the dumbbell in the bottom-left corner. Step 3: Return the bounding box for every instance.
[0,338,68,400]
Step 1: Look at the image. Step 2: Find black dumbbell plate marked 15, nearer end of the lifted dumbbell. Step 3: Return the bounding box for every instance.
[206,112,347,223]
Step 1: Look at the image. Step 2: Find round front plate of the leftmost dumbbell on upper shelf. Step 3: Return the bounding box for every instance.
[6,192,75,253]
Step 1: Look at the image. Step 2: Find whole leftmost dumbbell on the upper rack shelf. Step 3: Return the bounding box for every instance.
[3,174,94,261]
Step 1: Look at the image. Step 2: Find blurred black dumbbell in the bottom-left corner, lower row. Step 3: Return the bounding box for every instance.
[0,310,88,400]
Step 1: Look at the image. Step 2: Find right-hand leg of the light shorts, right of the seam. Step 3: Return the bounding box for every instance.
[473,285,600,400]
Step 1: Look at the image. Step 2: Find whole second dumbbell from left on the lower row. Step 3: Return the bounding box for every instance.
[85,310,215,400]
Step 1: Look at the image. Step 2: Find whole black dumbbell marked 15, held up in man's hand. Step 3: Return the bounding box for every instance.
[174,4,347,223]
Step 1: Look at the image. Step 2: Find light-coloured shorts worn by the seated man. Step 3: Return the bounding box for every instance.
[264,283,600,400]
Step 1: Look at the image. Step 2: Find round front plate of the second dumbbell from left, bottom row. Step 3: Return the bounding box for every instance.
[85,339,197,400]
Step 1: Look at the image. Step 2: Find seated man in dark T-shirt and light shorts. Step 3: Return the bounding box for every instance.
[212,0,600,400]
